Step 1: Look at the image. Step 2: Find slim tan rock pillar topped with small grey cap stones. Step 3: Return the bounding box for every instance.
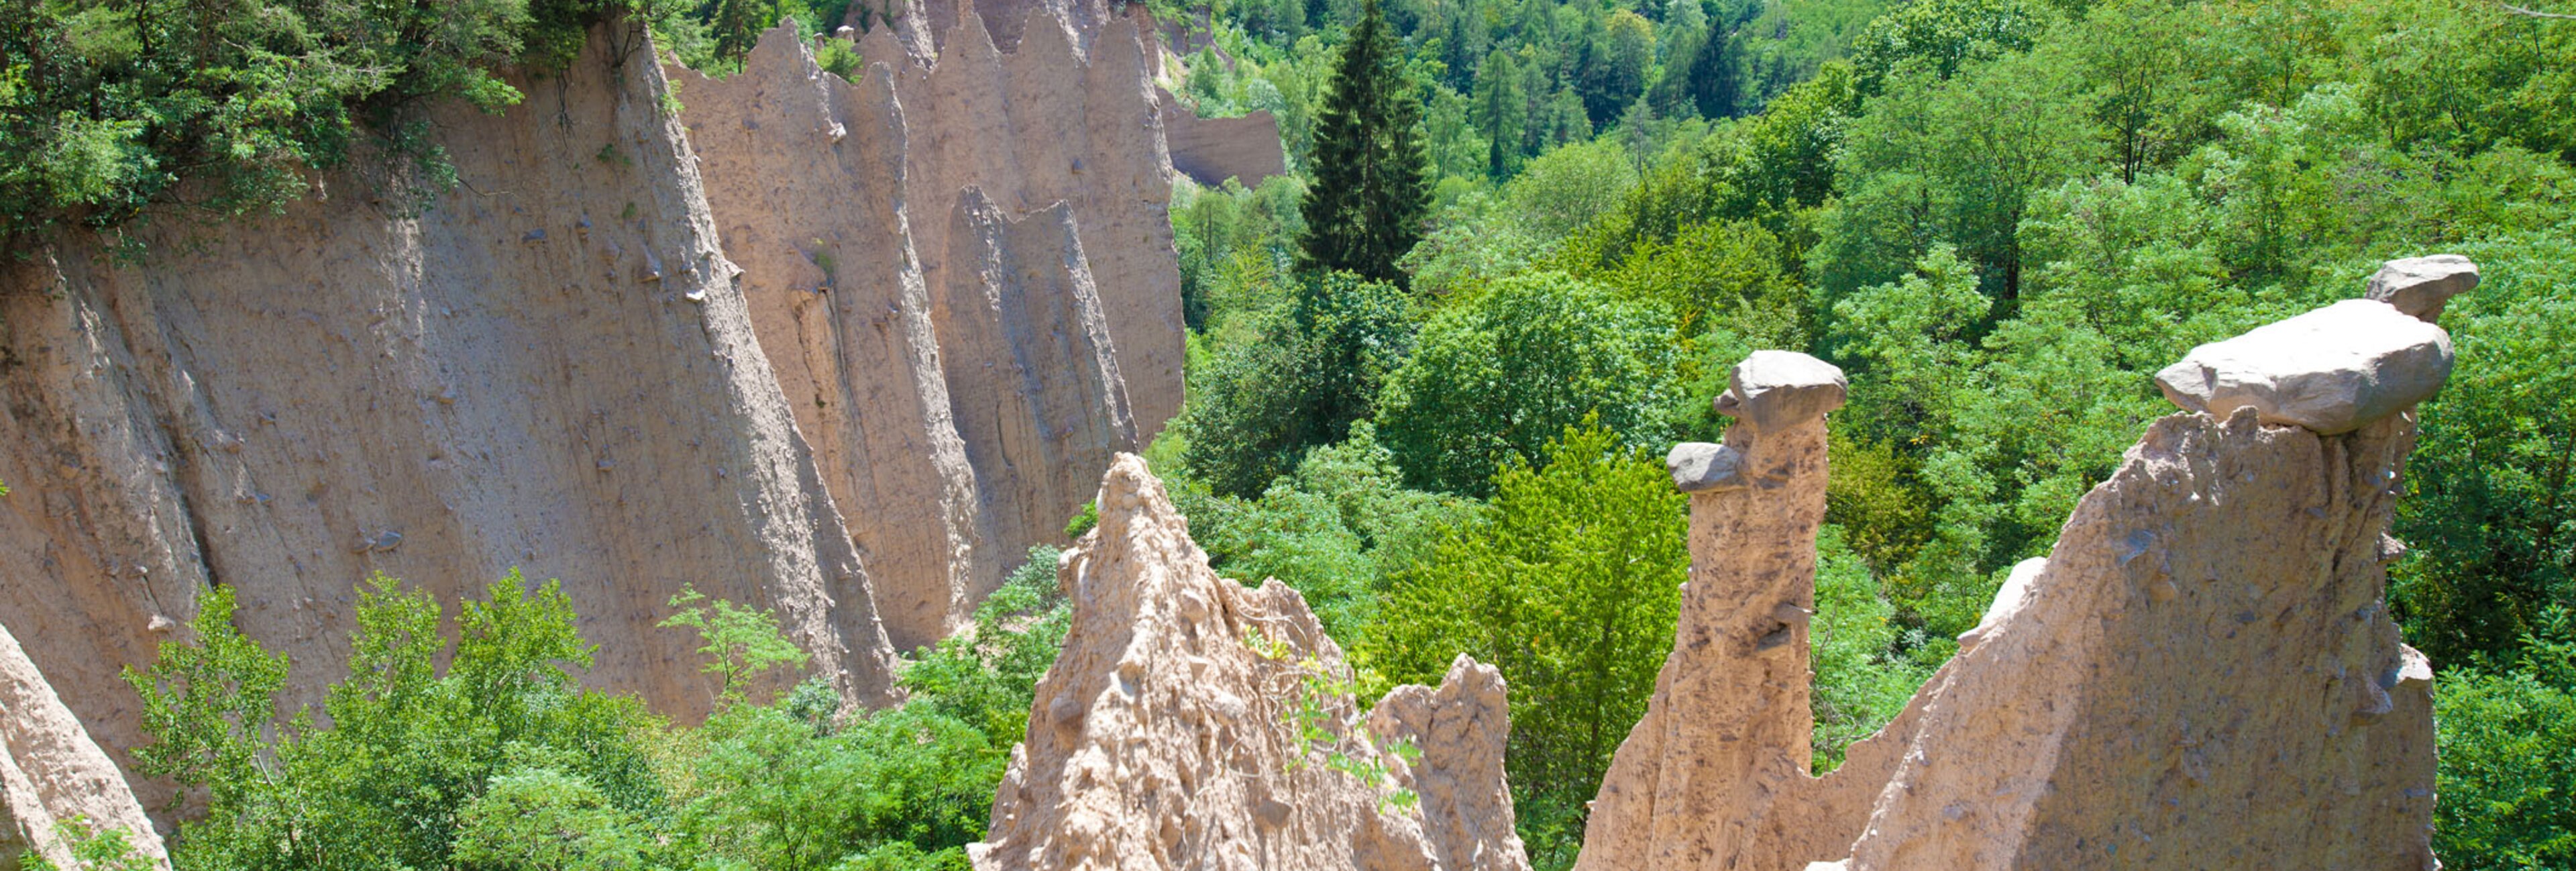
[1576,350,1911,871]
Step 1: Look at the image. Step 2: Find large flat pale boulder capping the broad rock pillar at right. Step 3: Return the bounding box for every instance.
[2156,299,2450,436]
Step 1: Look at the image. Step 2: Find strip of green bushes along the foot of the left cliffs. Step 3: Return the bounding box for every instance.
[125,549,1069,871]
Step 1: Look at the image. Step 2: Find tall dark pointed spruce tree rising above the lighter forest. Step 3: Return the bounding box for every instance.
[1298,0,1430,283]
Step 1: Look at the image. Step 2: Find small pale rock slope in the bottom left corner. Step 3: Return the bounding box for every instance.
[0,626,168,868]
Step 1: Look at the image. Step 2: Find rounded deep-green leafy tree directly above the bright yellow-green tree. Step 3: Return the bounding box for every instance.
[1378,273,1687,495]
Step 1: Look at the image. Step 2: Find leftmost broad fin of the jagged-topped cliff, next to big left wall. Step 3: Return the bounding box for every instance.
[669,28,989,650]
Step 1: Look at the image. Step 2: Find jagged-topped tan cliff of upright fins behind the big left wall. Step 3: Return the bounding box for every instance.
[672,15,1180,650]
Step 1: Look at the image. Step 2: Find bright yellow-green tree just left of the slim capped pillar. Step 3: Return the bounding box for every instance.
[1360,420,1690,866]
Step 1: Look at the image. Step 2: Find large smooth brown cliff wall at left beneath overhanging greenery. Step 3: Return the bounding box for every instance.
[0,25,892,807]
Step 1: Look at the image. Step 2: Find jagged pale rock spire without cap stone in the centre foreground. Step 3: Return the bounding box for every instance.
[969,454,1527,871]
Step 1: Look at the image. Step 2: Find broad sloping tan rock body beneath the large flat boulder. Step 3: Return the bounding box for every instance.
[1849,399,2434,871]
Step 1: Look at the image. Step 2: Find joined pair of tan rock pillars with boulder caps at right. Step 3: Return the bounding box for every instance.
[1576,266,2473,871]
